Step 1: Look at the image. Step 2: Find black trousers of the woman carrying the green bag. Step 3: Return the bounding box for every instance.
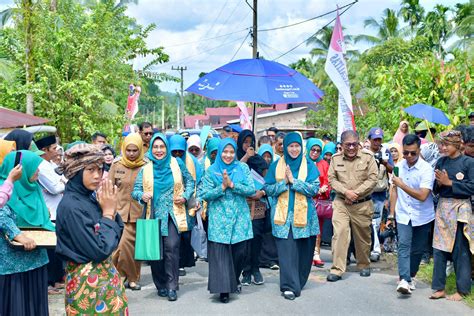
[149,218,181,290]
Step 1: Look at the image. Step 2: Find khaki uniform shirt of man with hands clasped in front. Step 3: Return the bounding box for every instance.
[328,150,378,200]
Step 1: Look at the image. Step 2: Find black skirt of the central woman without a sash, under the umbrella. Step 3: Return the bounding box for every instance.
[207,240,247,294]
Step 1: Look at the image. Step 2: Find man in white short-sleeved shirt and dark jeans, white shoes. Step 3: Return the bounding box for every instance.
[387,134,435,294]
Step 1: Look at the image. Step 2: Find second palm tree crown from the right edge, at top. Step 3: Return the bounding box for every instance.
[418,4,452,57]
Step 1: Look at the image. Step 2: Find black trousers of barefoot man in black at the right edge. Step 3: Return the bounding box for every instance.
[431,222,471,294]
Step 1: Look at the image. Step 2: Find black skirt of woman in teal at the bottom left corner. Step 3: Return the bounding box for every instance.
[0,265,49,316]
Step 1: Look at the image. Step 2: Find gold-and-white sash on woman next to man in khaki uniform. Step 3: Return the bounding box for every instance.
[274,155,308,227]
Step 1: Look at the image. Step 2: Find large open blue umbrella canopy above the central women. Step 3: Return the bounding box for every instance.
[186,59,324,104]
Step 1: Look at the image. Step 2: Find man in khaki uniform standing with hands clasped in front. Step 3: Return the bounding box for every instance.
[327,131,378,282]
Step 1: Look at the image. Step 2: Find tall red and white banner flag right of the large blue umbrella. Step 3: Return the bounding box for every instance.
[324,12,356,140]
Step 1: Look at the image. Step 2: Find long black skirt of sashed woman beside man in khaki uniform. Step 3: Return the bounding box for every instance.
[275,228,316,296]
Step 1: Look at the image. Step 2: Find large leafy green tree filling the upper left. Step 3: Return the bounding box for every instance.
[0,0,168,142]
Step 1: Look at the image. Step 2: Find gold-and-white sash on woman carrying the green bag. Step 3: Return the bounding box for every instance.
[143,157,188,232]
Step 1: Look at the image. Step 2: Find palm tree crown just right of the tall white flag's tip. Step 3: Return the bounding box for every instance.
[354,8,403,44]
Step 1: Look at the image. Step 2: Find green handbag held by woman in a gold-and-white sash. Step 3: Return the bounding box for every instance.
[135,204,163,261]
